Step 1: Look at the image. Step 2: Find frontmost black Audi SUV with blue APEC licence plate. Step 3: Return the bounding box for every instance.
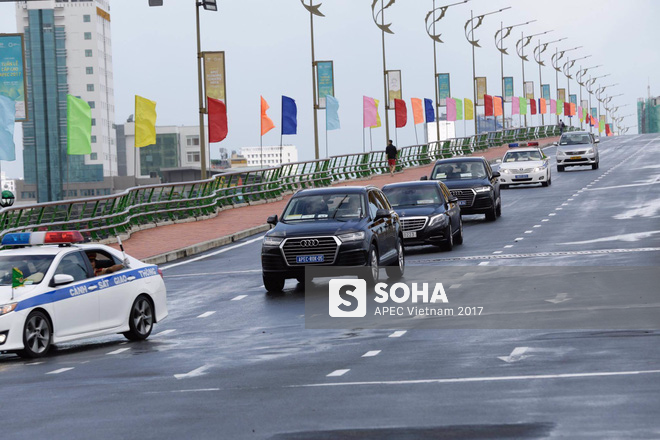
[261,186,405,292]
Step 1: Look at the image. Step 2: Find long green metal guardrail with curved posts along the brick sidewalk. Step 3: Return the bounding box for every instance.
[0,126,570,241]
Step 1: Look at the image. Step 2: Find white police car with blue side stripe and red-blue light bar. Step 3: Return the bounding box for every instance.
[0,231,167,358]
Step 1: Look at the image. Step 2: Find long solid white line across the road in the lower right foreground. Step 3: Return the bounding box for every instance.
[296,370,660,388]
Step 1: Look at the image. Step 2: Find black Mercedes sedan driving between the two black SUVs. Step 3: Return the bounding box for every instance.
[383,180,463,251]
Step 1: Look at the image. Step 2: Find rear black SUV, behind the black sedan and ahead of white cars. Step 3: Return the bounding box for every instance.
[422,157,502,221]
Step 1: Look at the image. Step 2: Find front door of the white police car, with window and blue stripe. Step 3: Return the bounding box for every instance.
[51,251,99,338]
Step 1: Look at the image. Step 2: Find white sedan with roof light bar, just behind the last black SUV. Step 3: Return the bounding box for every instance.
[499,147,552,188]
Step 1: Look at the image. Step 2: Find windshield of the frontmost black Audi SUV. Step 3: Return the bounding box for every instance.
[282,193,365,221]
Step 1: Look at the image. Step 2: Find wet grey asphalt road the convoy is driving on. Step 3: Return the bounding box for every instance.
[0,135,660,440]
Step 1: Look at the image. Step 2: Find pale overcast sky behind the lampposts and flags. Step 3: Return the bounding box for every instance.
[0,0,660,177]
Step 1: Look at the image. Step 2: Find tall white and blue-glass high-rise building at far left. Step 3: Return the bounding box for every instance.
[16,0,117,202]
